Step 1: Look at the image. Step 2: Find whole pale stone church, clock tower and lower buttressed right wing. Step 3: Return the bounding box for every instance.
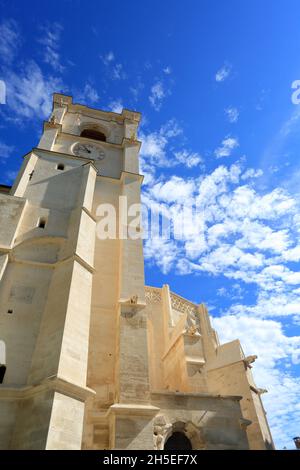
[0,93,273,450]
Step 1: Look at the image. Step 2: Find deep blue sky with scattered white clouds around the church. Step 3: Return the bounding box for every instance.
[0,0,300,449]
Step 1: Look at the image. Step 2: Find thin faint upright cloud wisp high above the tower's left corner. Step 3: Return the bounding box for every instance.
[39,23,64,72]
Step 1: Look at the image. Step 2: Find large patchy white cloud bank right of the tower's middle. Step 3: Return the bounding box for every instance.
[146,157,300,298]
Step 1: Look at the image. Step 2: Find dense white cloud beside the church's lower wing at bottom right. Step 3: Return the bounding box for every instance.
[213,314,300,449]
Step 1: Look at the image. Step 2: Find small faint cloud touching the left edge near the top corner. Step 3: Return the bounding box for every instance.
[0,19,21,64]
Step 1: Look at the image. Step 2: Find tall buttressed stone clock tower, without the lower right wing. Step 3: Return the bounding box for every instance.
[0,94,148,449]
